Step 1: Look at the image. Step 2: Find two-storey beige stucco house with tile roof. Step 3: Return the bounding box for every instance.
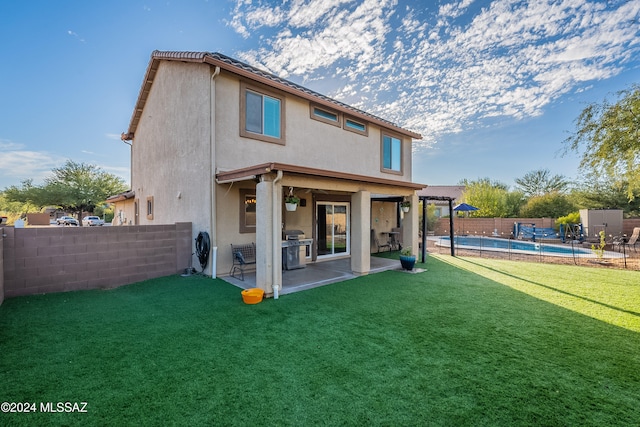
[114,51,424,294]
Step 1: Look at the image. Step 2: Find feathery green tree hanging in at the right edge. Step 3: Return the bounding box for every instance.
[565,84,640,200]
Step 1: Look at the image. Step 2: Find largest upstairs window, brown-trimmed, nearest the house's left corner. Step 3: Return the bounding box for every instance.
[240,84,284,144]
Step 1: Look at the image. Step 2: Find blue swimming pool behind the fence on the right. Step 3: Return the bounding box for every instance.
[436,236,622,258]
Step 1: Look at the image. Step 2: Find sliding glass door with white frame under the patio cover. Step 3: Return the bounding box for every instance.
[317,202,351,257]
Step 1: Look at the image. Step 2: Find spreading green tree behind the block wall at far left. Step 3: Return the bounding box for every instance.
[4,160,127,219]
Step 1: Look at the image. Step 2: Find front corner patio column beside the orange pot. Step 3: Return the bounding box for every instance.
[256,175,282,294]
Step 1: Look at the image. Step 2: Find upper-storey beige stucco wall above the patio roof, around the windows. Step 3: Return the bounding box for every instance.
[216,72,411,181]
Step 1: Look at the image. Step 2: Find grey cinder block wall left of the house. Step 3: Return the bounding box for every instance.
[2,223,192,298]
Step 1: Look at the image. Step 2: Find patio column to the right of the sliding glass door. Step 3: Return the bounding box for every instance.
[351,191,371,275]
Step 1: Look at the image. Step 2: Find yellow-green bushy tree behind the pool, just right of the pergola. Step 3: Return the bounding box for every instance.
[461,178,523,218]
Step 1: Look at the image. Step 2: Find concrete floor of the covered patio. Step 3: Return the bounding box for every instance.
[221,257,402,295]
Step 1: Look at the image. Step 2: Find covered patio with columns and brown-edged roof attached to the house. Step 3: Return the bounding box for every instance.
[216,162,423,296]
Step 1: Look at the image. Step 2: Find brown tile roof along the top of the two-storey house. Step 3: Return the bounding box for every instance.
[122,50,422,140]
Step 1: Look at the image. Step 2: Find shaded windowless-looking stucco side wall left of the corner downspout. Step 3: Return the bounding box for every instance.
[131,62,212,268]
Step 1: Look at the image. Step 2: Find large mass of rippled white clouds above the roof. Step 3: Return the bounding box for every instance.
[230,0,640,147]
